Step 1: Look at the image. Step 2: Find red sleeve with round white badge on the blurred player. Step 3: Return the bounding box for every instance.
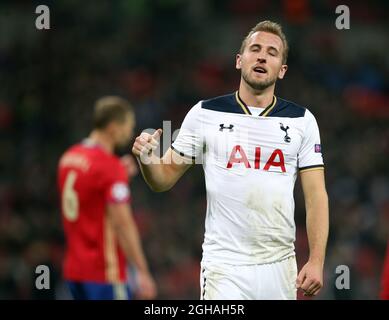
[105,163,131,203]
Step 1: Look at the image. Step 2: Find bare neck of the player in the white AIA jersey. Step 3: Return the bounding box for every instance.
[239,81,275,108]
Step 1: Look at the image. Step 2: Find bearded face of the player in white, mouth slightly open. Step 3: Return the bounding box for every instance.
[236,31,287,90]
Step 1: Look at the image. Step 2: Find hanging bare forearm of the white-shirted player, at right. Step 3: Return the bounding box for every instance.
[306,191,329,265]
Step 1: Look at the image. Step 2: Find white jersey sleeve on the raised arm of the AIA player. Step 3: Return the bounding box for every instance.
[171,102,203,161]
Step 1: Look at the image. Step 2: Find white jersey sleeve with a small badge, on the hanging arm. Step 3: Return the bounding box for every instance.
[298,110,324,172]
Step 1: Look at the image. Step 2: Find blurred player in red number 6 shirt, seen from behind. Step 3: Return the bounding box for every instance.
[58,97,156,300]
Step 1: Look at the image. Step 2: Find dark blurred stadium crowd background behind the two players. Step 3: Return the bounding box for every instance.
[0,0,389,299]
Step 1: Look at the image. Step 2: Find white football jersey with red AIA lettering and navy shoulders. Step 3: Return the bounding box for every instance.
[172,92,324,265]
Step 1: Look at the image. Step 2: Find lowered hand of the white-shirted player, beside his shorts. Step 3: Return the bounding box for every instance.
[296,261,323,297]
